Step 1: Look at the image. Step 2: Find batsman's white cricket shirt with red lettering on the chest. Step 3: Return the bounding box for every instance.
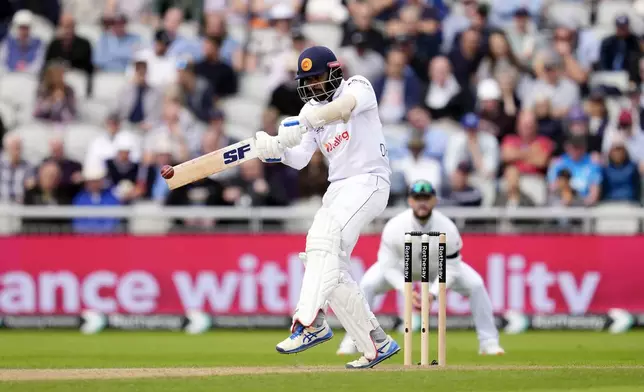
[283,75,391,183]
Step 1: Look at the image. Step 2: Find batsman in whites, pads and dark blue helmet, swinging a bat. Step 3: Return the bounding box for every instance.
[255,46,400,369]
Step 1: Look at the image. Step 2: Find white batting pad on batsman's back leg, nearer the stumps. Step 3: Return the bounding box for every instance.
[329,271,379,360]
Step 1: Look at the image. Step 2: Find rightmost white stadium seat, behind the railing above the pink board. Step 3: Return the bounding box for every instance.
[593,203,642,235]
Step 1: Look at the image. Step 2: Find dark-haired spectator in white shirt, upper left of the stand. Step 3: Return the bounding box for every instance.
[126,30,177,88]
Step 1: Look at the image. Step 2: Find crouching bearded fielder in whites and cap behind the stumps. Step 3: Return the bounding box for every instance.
[337,180,505,355]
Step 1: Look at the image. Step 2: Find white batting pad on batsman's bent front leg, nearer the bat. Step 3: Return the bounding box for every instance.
[293,208,342,327]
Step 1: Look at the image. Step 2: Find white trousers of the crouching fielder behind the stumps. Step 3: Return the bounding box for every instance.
[360,257,499,342]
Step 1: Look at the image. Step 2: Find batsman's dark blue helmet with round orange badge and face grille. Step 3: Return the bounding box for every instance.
[295,46,344,103]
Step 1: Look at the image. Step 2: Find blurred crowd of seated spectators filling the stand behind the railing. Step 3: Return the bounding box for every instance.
[0,0,644,232]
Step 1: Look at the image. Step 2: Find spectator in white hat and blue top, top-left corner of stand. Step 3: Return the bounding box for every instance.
[0,10,45,74]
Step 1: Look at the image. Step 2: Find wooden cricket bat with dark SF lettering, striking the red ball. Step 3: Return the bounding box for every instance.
[165,121,299,190]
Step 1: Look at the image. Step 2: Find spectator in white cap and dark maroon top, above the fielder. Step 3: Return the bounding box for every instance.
[476,79,516,143]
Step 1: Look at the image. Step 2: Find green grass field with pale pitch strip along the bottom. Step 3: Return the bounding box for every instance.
[0,331,644,392]
